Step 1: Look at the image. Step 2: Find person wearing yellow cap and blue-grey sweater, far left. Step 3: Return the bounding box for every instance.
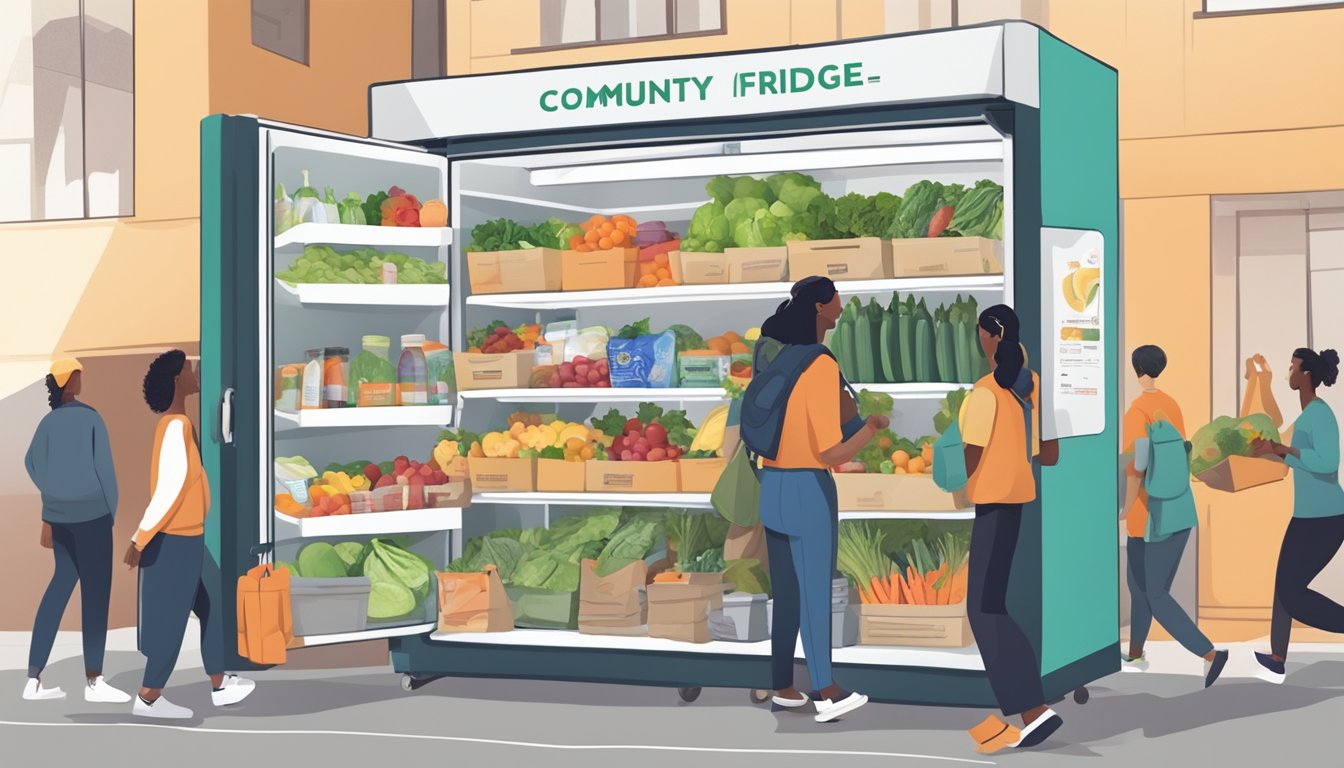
[23,359,130,703]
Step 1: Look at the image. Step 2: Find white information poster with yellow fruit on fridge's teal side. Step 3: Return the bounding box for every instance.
[1040,227,1107,440]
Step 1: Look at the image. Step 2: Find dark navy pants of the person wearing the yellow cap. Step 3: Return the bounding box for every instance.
[28,515,112,678]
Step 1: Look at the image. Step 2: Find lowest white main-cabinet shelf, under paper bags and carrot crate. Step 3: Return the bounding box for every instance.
[430,629,985,671]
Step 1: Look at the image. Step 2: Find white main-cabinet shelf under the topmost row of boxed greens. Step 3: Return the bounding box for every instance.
[466,274,1004,311]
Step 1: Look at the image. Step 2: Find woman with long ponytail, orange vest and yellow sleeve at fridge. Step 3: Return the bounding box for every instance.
[958,304,1063,752]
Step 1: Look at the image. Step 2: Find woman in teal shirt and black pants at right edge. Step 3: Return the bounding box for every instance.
[1253,348,1344,685]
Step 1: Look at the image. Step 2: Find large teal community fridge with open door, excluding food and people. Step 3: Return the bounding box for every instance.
[202,23,1121,706]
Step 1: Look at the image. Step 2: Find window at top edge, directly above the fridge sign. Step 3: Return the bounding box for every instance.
[540,0,724,48]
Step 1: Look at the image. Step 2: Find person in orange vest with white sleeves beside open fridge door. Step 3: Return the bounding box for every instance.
[125,350,255,720]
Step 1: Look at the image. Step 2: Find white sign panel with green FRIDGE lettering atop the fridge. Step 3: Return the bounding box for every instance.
[371,24,1039,141]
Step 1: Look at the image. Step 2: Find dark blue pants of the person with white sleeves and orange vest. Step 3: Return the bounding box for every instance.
[140,534,224,689]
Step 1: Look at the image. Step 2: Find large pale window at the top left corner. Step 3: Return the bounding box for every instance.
[0,0,136,222]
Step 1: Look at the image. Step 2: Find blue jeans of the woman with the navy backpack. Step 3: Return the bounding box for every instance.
[761,469,840,690]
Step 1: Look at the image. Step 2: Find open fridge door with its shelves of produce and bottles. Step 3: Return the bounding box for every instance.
[202,116,461,663]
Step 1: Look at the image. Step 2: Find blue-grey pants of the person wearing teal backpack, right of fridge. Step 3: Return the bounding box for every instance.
[1125,531,1214,656]
